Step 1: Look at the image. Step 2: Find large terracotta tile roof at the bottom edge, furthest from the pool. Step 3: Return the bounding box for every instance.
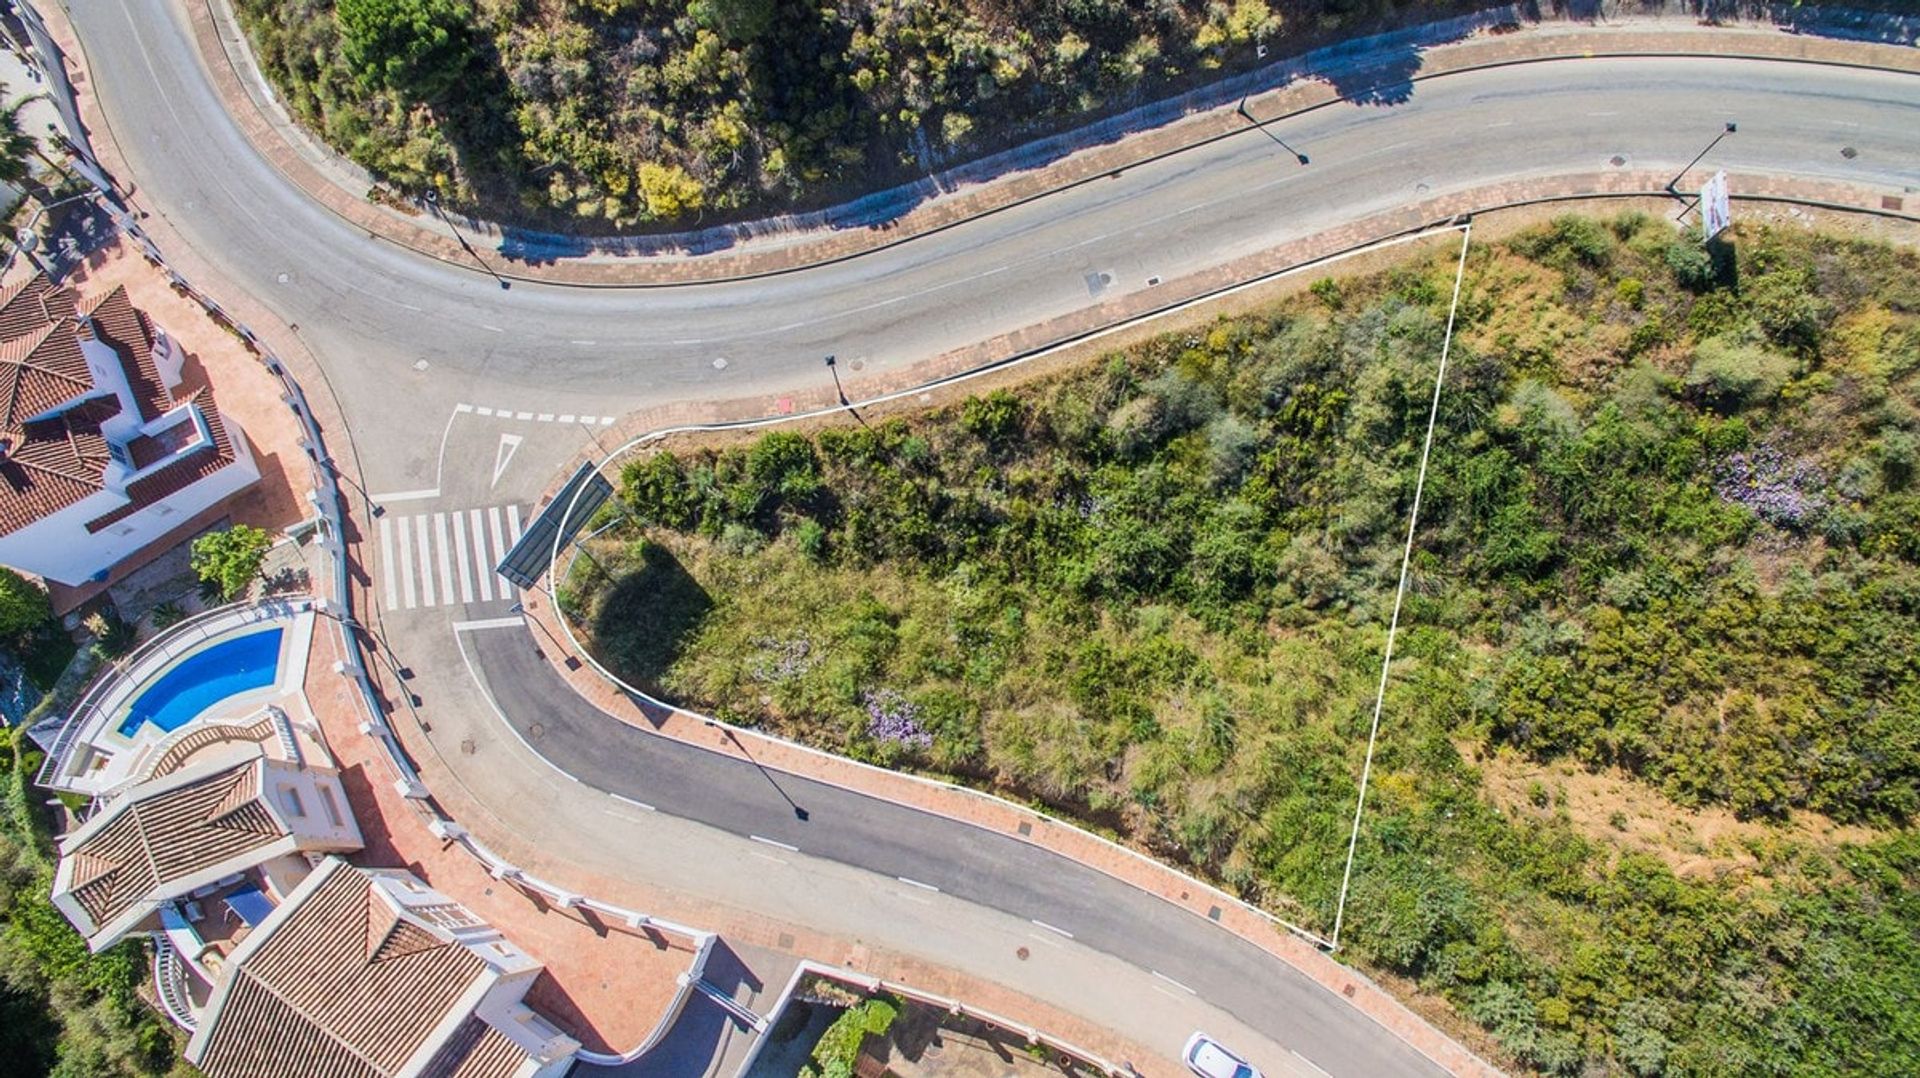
[194,861,526,1078]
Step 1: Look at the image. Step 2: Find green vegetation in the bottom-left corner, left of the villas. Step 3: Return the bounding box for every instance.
[0,730,198,1078]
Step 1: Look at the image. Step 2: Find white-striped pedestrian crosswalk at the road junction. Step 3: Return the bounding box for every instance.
[378,505,522,611]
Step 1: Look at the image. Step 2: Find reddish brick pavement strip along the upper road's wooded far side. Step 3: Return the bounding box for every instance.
[172,0,1920,286]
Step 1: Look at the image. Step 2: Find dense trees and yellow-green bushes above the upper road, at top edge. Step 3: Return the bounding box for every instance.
[236,0,1467,233]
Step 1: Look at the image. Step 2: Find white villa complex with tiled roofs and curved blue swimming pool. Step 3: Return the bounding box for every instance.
[43,600,580,1078]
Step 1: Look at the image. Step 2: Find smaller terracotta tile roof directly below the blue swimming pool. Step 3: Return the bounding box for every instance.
[61,757,288,930]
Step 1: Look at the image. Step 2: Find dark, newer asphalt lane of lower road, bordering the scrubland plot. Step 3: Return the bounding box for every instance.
[468,632,1444,1076]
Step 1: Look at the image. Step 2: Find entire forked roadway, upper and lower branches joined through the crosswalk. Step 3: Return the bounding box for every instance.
[48,0,1920,1074]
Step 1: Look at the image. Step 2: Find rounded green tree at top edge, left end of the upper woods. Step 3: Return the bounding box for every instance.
[334,0,472,100]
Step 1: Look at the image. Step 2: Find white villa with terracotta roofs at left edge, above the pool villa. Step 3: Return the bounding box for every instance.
[0,275,259,586]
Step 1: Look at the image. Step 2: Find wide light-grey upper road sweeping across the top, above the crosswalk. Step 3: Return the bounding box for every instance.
[71,0,1920,490]
